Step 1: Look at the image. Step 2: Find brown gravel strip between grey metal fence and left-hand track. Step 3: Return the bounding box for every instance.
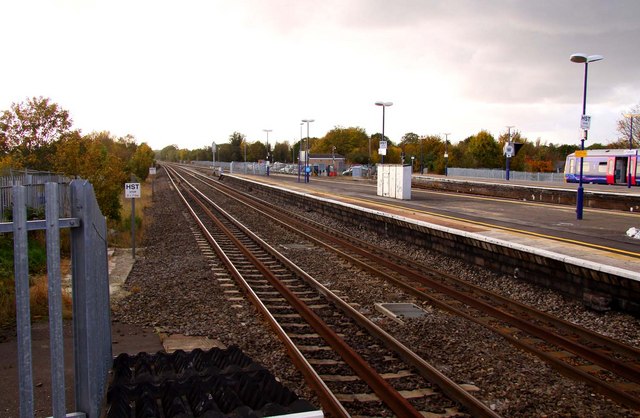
[112,171,317,404]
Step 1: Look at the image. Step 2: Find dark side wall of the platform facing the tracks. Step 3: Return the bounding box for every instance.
[225,177,640,314]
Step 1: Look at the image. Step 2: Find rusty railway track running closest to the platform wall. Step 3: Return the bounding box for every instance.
[171,164,640,409]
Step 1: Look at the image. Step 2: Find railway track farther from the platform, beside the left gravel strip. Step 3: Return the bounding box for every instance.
[167,168,497,417]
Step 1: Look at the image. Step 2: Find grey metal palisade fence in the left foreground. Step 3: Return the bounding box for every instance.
[0,180,112,418]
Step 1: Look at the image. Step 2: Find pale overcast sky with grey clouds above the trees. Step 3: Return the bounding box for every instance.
[0,0,640,149]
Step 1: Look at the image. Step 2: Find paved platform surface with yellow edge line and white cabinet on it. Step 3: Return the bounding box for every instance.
[231,173,640,283]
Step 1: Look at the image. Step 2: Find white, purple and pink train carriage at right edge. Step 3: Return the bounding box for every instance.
[564,149,640,186]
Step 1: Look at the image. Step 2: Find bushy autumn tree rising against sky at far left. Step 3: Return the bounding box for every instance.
[0,97,72,170]
